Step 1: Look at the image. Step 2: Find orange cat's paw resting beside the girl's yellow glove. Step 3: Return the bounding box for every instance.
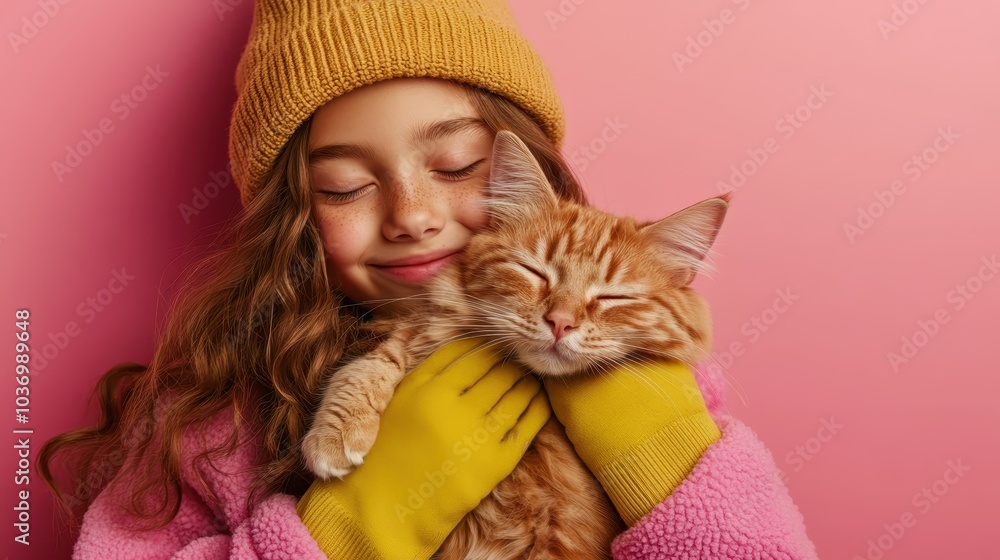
[302,407,379,480]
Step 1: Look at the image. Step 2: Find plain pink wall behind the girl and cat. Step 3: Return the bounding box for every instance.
[0,0,1000,560]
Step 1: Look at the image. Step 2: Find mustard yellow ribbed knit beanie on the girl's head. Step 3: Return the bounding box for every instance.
[229,0,565,205]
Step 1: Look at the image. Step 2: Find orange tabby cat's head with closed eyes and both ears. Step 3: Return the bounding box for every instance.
[438,131,729,375]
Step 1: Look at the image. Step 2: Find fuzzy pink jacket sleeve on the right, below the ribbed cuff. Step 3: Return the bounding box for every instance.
[611,364,817,560]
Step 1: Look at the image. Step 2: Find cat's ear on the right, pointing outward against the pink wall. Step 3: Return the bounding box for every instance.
[639,193,732,286]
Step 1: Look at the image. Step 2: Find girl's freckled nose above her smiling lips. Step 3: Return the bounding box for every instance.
[382,181,447,241]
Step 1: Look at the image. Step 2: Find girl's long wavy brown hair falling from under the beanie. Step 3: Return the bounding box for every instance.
[38,83,587,529]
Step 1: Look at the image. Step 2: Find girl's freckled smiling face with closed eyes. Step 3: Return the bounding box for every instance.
[309,78,493,310]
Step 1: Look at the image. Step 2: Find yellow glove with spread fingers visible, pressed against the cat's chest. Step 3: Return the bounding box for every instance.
[298,340,552,558]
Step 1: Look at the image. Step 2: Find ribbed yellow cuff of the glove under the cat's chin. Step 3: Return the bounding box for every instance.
[595,412,722,527]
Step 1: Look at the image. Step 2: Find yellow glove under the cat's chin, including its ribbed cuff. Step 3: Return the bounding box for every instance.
[544,361,722,526]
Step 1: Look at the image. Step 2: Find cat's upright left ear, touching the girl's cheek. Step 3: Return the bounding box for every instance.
[482,130,558,224]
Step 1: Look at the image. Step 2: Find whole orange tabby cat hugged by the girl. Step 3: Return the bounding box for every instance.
[303,131,729,560]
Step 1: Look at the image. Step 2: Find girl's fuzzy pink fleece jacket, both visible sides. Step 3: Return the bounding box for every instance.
[73,369,817,560]
